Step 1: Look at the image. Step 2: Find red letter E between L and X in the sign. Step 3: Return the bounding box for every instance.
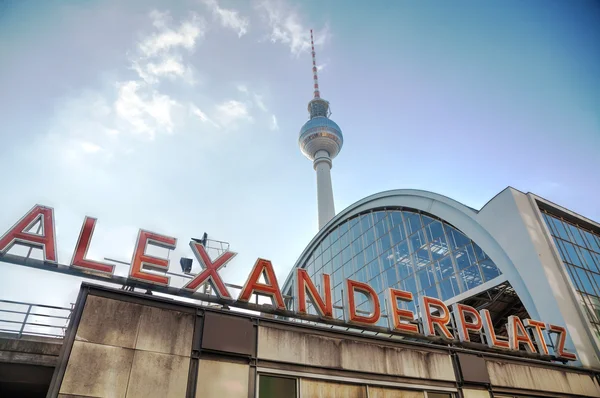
[129,229,177,286]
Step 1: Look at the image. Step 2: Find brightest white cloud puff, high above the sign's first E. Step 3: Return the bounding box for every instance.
[114,81,179,139]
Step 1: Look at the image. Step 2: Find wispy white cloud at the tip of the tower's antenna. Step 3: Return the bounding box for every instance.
[258,0,329,56]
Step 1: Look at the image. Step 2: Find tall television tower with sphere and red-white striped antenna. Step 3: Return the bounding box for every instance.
[298,29,344,230]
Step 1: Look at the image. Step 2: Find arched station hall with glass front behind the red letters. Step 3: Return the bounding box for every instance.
[283,188,600,369]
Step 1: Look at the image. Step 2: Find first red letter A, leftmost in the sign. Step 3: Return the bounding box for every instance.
[0,205,58,263]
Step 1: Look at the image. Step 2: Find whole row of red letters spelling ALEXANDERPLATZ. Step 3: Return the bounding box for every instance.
[0,205,577,361]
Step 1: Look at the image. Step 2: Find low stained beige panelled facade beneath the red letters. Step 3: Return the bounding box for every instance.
[48,284,600,398]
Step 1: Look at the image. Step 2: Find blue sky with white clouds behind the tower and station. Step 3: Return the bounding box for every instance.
[0,0,600,305]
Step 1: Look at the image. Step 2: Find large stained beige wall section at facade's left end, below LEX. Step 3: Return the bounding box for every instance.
[59,296,194,398]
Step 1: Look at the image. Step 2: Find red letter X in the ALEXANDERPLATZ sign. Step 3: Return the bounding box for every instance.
[183,241,237,299]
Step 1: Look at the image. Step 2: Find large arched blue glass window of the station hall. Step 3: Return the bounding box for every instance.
[292,209,501,326]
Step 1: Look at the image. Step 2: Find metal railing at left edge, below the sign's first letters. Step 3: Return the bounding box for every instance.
[0,300,73,339]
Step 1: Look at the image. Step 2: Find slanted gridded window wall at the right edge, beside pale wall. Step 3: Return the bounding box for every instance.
[543,211,600,344]
